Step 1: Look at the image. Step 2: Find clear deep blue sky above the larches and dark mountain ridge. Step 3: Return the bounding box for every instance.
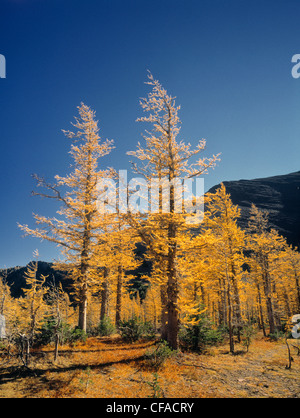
[0,0,300,267]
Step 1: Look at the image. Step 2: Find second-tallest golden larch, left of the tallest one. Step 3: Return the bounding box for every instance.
[19,103,113,330]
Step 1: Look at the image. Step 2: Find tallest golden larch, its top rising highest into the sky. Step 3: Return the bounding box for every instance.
[128,73,218,349]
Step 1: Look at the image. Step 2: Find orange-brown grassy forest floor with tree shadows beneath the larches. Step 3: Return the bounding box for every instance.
[0,336,300,398]
